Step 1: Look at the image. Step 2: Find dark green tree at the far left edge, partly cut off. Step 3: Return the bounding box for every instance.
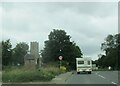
[2,39,12,66]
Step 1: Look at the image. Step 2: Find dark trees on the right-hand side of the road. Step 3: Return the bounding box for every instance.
[96,34,120,69]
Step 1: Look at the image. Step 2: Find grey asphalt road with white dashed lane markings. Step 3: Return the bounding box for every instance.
[66,71,118,84]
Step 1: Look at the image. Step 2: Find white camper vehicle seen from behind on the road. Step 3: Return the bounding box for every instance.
[76,58,92,74]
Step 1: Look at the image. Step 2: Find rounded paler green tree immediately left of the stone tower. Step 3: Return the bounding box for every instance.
[12,42,29,65]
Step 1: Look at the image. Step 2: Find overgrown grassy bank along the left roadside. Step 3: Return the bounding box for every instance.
[2,67,66,83]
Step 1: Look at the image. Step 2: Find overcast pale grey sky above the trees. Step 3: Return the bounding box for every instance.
[0,2,118,60]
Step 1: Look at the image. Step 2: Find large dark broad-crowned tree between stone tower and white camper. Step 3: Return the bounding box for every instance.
[41,29,82,68]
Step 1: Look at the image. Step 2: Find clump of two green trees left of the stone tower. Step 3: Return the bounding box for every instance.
[1,39,29,69]
